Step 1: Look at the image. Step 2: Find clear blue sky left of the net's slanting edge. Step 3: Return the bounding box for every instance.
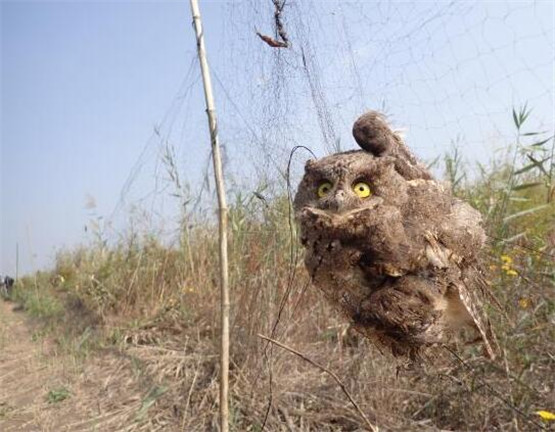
[0,2,200,272]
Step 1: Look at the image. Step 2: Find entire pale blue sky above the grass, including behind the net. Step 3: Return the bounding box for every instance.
[0,0,555,274]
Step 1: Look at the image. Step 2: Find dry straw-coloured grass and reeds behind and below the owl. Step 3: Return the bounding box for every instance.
[7,115,555,432]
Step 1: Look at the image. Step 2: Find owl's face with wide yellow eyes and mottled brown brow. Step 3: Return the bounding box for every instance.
[294,151,405,214]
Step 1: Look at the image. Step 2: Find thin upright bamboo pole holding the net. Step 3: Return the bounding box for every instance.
[190,0,229,432]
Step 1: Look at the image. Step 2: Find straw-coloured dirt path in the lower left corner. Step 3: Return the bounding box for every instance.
[0,301,149,432]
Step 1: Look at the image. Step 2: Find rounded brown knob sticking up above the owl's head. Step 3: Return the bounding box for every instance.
[353,111,396,156]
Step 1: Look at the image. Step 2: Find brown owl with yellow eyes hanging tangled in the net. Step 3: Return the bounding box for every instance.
[294,112,494,358]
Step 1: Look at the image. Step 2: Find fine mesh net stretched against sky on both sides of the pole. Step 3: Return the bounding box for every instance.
[106,0,555,237]
